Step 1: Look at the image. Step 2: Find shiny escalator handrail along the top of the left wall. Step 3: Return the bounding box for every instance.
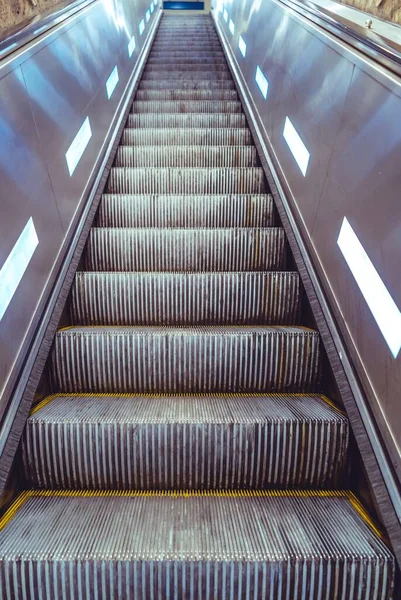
[0,0,99,60]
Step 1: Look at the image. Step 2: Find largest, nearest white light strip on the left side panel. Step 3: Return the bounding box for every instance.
[0,217,39,321]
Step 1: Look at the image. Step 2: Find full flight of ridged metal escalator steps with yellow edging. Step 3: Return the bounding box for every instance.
[0,11,395,600]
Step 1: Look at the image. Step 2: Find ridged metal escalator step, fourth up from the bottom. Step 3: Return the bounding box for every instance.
[71,271,300,326]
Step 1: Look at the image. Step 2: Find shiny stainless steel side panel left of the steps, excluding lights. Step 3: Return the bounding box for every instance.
[0,0,159,418]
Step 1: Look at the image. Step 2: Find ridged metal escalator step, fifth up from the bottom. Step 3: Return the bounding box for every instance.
[86,227,285,272]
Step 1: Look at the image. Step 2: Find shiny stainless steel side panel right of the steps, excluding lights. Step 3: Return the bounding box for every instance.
[213,0,401,473]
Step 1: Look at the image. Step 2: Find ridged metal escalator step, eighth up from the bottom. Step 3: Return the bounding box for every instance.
[114,146,258,167]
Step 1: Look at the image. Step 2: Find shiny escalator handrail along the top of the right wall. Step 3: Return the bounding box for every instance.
[277,0,401,75]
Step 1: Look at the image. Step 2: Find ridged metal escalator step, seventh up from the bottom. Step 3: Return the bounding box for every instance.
[107,167,266,194]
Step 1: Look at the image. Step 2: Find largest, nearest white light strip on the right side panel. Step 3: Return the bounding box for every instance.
[337,217,401,358]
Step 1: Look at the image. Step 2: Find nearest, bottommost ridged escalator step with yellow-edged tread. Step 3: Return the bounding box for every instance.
[0,491,395,600]
